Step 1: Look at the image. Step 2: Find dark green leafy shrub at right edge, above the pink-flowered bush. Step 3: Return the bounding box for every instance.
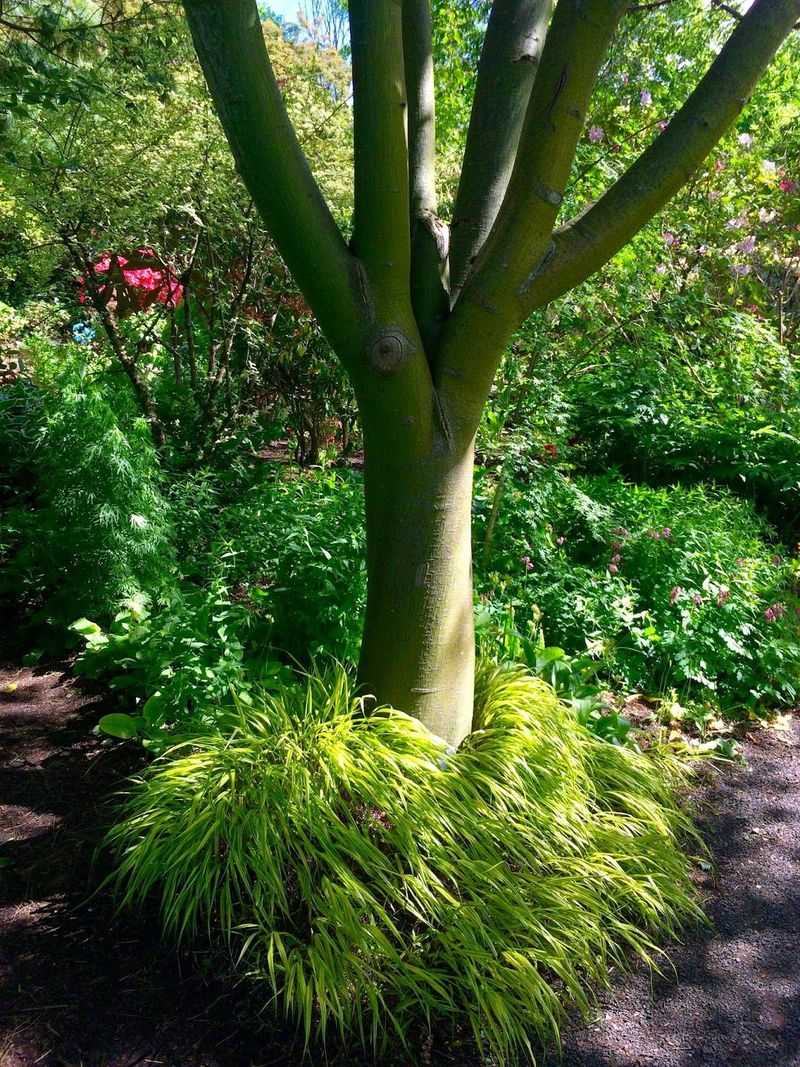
[570,303,800,529]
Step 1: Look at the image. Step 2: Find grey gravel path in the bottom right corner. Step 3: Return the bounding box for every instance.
[546,720,800,1067]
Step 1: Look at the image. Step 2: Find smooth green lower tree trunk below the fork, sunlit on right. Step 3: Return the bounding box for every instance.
[359,424,475,745]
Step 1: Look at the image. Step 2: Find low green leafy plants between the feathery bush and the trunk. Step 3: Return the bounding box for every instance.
[173,465,366,663]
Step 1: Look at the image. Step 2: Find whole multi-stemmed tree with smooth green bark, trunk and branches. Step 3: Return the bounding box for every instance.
[183,0,800,744]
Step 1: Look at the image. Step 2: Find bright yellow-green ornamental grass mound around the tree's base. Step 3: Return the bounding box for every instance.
[111,666,701,1062]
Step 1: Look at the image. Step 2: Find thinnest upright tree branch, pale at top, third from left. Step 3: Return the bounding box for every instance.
[403,0,449,351]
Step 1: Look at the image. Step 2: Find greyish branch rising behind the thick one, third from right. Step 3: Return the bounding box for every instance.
[450,0,553,301]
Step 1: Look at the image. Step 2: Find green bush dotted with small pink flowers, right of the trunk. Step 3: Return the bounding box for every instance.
[477,471,800,707]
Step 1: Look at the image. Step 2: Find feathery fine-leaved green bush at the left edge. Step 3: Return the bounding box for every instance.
[0,347,174,623]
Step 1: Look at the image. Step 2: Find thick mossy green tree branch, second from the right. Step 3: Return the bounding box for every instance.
[433,0,628,439]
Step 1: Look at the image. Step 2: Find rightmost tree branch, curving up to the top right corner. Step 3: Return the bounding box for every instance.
[526,0,800,314]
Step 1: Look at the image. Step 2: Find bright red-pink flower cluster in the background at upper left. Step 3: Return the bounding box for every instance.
[78,249,183,319]
